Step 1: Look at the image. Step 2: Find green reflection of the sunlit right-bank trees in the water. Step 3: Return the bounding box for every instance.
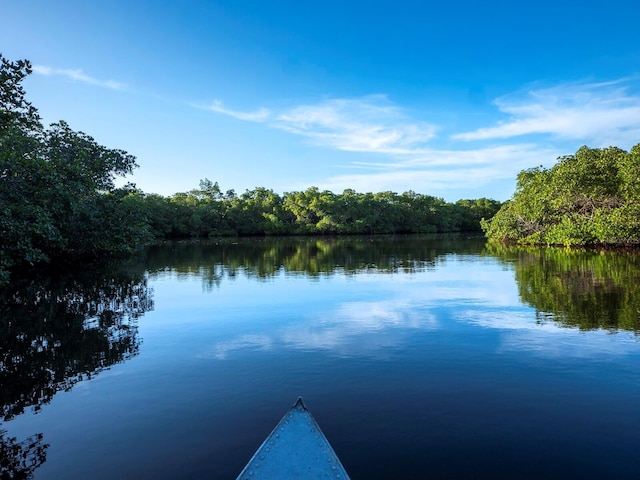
[487,243,640,333]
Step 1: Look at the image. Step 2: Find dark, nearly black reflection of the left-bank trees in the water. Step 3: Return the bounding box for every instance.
[0,266,153,478]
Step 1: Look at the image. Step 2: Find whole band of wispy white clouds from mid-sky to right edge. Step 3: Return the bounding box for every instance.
[202,78,640,198]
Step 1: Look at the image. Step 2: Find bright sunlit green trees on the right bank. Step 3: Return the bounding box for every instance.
[482,145,640,246]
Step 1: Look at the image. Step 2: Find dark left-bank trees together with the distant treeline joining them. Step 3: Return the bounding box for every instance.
[0,55,500,285]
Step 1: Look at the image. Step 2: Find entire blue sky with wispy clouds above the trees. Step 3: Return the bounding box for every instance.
[0,0,640,201]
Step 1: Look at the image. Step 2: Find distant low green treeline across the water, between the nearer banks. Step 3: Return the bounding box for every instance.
[142,183,501,238]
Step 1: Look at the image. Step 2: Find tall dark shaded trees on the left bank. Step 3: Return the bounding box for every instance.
[0,55,149,285]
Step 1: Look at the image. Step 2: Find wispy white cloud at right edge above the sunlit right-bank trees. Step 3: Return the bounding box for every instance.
[452,79,640,146]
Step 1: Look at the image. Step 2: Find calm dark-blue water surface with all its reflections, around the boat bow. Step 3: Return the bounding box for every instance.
[0,237,640,480]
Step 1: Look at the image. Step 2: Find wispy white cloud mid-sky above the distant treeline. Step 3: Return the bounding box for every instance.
[202,95,568,196]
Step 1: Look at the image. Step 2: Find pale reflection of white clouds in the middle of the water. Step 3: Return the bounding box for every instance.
[196,258,520,359]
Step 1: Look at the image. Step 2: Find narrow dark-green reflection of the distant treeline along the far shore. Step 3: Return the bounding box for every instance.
[148,235,484,288]
